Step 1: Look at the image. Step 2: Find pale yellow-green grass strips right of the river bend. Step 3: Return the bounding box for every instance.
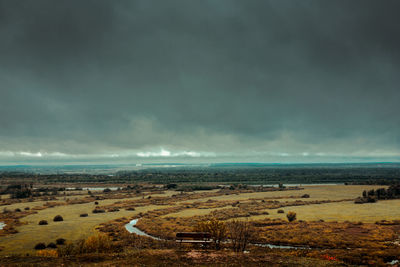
[170,185,400,223]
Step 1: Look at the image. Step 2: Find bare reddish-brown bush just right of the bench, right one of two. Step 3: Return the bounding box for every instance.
[227,220,254,252]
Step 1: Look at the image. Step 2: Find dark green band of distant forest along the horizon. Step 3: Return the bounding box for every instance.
[0,165,400,185]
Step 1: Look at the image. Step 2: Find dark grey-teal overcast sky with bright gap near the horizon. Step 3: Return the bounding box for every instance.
[0,0,400,165]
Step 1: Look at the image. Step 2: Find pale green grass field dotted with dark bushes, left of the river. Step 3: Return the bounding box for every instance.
[0,199,167,255]
